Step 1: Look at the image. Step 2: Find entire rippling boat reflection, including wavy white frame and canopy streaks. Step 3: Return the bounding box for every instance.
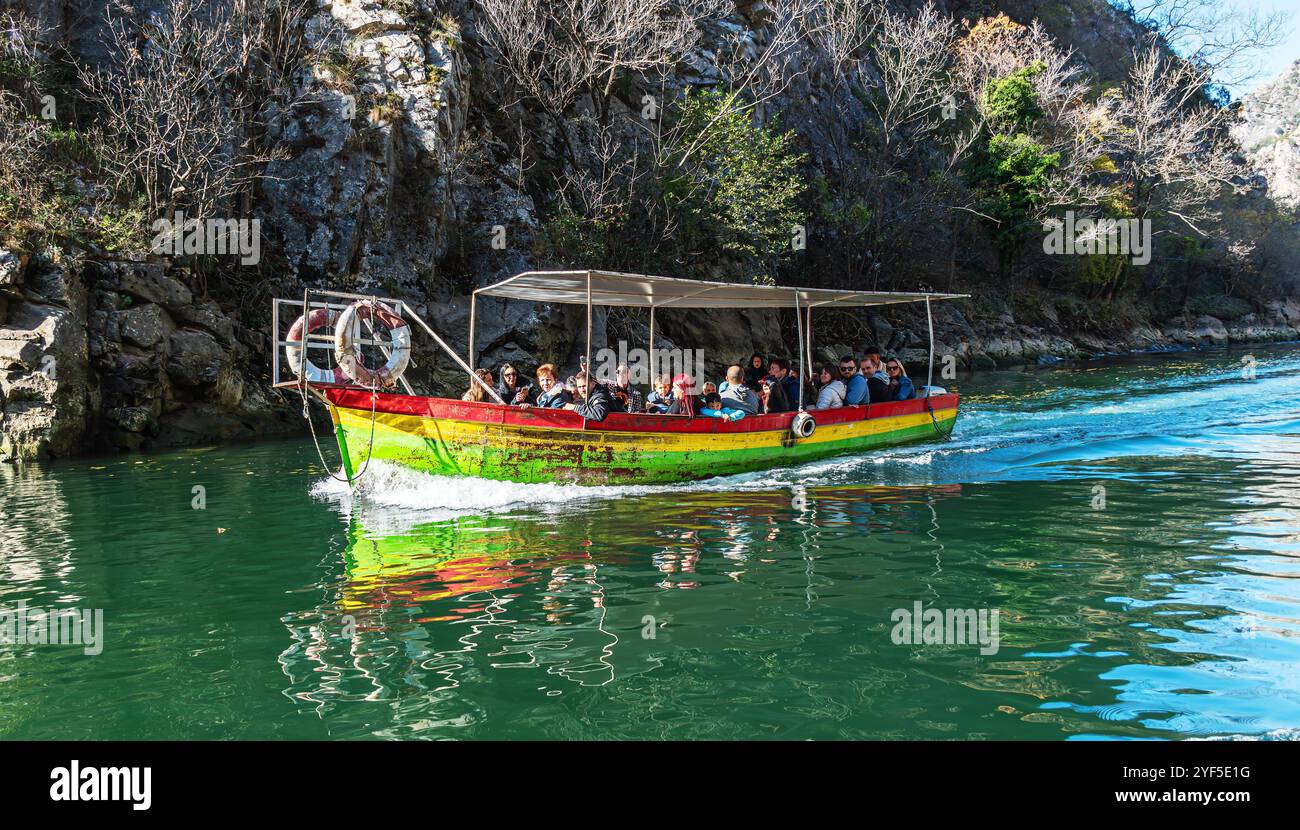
[281,484,961,705]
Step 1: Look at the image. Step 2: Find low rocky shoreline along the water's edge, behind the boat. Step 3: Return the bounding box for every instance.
[0,259,1300,463]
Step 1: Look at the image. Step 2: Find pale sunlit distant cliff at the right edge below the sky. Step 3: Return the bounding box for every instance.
[1232,61,1300,208]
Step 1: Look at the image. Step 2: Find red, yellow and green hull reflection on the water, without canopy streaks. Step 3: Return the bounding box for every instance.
[342,484,961,608]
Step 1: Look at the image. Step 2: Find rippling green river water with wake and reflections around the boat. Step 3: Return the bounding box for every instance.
[0,347,1300,740]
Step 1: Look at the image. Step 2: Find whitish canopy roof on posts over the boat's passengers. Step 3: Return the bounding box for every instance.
[475,271,969,308]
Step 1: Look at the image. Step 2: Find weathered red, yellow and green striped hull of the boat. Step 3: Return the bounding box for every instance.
[322,388,958,485]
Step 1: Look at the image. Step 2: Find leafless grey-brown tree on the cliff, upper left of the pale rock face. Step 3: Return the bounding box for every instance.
[81,0,311,221]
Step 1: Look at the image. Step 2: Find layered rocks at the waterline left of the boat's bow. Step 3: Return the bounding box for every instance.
[0,253,298,461]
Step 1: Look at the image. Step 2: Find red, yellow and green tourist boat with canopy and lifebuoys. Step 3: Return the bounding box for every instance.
[273,271,959,485]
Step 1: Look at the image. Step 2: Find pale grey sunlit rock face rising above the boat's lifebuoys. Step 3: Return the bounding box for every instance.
[263,0,469,294]
